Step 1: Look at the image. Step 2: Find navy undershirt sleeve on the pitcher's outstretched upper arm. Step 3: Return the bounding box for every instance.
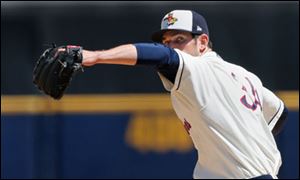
[134,43,179,83]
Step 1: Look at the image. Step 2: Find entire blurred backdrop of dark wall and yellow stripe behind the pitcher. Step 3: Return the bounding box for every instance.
[1,1,299,179]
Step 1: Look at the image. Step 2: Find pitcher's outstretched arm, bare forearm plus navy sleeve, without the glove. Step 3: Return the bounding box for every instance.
[83,43,179,83]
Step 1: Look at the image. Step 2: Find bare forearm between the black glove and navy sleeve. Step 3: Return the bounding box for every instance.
[82,44,137,66]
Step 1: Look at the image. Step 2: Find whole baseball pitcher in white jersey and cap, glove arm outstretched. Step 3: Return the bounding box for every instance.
[34,10,288,179]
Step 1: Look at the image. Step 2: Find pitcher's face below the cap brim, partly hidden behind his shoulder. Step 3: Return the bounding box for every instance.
[162,31,199,56]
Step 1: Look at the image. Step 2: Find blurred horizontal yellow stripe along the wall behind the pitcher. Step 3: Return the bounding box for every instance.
[1,91,299,114]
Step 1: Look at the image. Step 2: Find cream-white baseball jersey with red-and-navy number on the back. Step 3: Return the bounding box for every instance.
[159,49,284,179]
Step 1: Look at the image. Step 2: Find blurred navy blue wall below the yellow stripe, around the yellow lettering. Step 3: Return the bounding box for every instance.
[1,111,299,179]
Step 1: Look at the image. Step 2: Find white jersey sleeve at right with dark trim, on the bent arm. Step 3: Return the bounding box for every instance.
[262,87,284,130]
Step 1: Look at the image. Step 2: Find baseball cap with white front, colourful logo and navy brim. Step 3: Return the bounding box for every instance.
[151,10,209,43]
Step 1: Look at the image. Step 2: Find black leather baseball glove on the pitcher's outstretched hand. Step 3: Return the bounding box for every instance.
[33,44,83,100]
